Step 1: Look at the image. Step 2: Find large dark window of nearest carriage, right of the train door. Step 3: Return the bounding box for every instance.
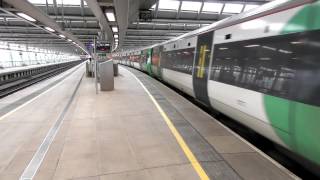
[210,30,320,105]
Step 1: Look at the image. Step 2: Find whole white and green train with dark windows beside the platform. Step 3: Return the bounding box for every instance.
[112,0,320,172]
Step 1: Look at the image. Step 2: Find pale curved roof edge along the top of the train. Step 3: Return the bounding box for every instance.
[120,0,317,52]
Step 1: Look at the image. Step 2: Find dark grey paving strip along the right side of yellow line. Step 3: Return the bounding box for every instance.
[127,68,241,180]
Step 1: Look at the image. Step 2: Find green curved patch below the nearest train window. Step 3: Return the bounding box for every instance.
[264,95,320,164]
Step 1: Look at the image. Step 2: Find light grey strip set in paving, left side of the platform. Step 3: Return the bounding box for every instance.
[20,74,84,180]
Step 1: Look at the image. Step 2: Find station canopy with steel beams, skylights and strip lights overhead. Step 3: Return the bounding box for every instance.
[0,0,268,57]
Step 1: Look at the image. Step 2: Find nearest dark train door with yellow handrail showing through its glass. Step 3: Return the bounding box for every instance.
[193,32,213,105]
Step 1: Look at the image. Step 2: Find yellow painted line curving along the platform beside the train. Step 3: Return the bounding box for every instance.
[122,68,210,180]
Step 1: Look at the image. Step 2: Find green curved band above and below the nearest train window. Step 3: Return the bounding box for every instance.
[264,1,320,164]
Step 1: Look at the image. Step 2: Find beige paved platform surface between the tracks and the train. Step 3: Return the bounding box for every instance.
[0,64,293,180]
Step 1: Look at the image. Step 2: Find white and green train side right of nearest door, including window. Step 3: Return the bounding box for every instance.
[209,2,320,164]
